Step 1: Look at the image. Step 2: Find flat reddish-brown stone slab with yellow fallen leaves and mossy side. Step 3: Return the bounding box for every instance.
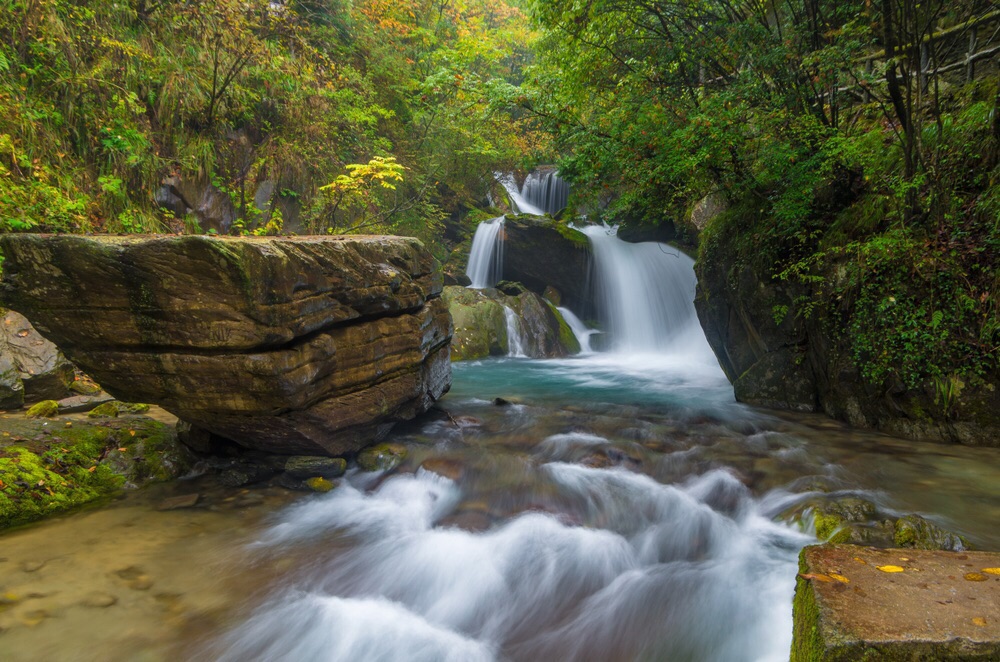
[791,545,1000,662]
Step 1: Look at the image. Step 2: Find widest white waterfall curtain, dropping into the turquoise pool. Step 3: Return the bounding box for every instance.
[581,225,714,361]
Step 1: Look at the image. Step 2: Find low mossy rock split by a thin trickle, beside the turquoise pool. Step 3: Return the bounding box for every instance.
[444,286,580,361]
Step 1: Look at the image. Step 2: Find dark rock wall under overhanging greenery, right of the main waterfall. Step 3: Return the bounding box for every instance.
[695,210,1000,446]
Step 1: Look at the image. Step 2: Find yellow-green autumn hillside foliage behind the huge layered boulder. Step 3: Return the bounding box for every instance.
[0,0,543,249]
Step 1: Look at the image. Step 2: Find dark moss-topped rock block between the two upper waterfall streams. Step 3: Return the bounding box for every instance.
[503,214,590,310]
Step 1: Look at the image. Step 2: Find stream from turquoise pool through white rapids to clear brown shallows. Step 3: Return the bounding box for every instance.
[0,350,1000,661]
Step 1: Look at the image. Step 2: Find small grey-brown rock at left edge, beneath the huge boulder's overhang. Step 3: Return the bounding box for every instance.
[0,310,74,409]
